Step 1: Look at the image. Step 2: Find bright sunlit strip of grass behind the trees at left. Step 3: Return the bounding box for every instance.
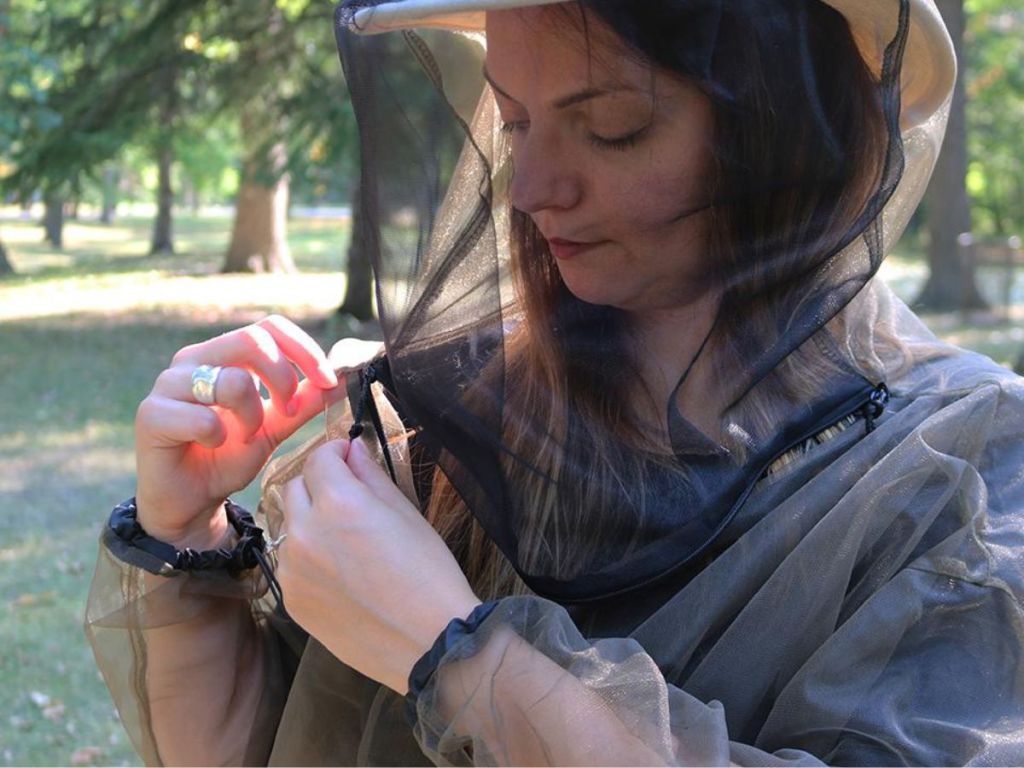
[0,210,347,323]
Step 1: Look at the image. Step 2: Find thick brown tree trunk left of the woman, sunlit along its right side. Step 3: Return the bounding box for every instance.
[221,111,295,272]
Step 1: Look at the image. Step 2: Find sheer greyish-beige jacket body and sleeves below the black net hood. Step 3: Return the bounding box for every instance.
[87,286,1024,765]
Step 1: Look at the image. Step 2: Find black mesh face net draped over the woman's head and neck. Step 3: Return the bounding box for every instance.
[337,0,909,601]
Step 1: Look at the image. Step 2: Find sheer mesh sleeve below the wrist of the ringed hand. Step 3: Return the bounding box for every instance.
[85,530,304,765]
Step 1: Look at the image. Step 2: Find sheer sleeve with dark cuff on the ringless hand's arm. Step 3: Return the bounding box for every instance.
[416,569,1024,765]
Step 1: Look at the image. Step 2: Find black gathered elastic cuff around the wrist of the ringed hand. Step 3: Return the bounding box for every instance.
[109,498,266,574]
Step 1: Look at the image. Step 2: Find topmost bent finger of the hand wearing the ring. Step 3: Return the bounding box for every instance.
[172,326,299,412]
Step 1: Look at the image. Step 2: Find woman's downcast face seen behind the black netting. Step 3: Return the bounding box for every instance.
[486,8,713,311]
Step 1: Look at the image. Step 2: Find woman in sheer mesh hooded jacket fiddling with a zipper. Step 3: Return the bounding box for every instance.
[88,0,1024,765]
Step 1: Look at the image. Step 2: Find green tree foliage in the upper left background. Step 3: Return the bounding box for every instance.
[0,0,354,208]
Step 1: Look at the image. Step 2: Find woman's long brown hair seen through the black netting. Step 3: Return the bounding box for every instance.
[427,0,889,599]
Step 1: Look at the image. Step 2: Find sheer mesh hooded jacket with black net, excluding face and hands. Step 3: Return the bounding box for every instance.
[86,0,1024,765]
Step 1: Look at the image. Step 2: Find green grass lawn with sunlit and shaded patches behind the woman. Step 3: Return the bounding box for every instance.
[0,211,1024,765]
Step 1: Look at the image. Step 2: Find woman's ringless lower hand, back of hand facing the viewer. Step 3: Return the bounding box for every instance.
[276,440,480,694]
